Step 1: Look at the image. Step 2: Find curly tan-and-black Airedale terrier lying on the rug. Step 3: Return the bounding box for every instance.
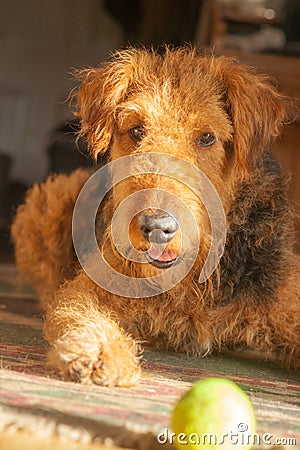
[12,47,300,386]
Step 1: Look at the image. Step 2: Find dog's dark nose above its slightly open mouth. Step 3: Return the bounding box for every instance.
[138,211,179,244]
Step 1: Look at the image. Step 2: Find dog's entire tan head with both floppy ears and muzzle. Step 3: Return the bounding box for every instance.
[75,49,284,275]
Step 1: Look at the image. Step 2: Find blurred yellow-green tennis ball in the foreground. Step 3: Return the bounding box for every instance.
[172,377,256,450]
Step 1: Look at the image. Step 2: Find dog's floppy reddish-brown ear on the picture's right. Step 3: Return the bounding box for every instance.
[216,57,286,176]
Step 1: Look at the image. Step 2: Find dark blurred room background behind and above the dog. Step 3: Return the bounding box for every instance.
[0,0,300,262]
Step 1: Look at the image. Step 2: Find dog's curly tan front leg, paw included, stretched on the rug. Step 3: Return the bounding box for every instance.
[44,273,140,386]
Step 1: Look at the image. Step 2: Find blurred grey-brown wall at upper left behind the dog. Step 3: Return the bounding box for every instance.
[0,0,123,183]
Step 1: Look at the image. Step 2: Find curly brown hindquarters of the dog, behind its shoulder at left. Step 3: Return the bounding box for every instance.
[11,169,90,295]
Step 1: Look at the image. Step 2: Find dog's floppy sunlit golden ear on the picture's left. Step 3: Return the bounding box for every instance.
[70,51,136,159]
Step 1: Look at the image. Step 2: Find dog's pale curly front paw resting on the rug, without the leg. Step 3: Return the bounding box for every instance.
[49,326,141,387]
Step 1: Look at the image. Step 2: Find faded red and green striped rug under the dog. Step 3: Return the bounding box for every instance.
[0,265,300,450]
